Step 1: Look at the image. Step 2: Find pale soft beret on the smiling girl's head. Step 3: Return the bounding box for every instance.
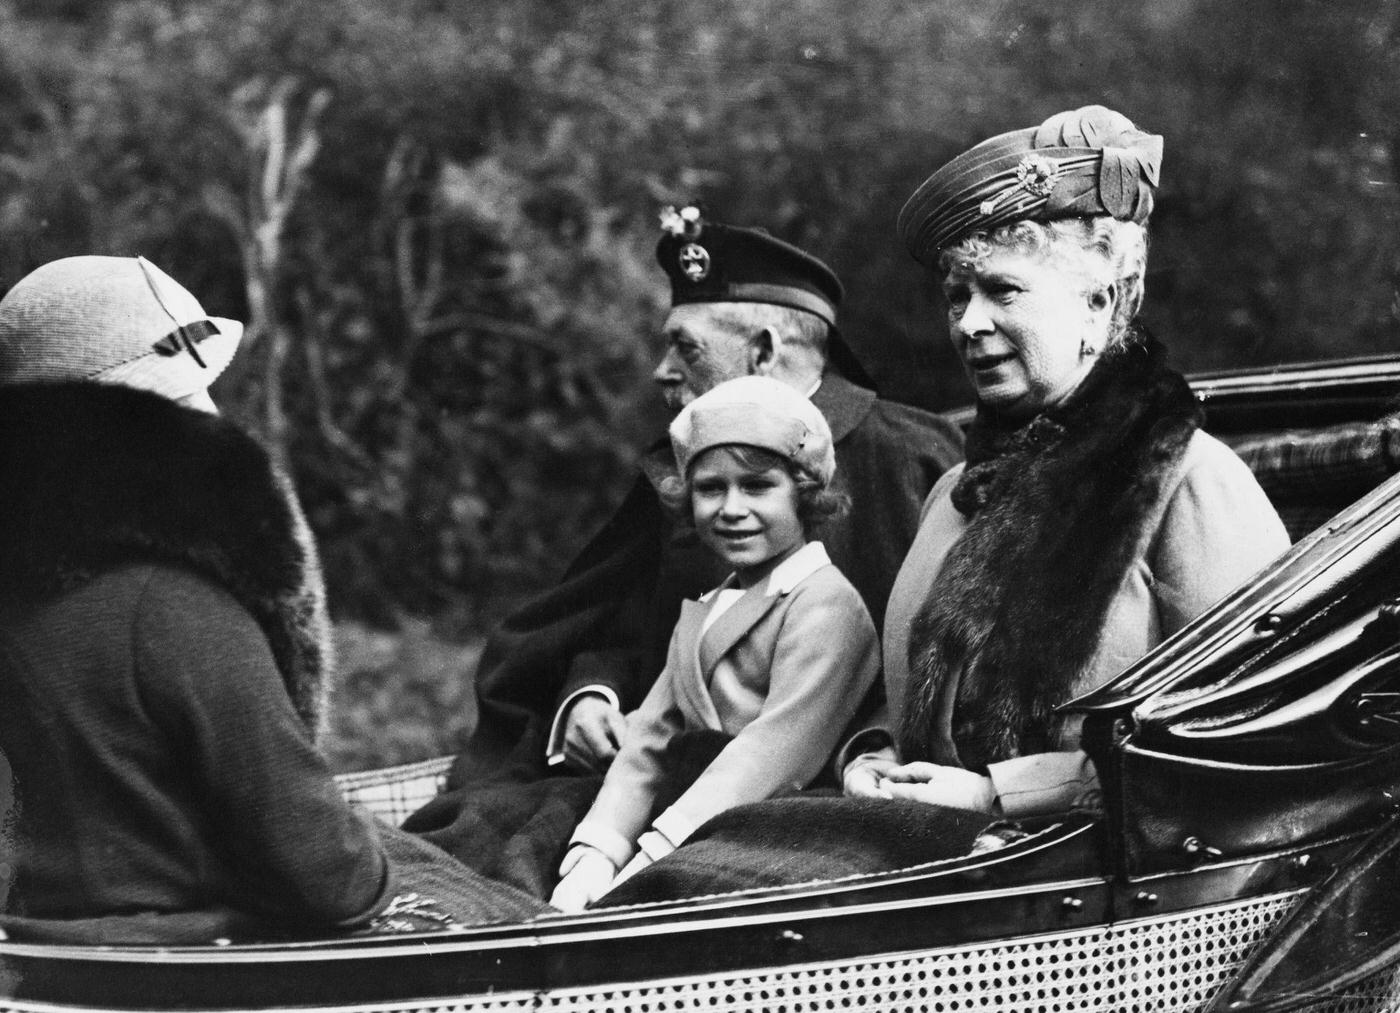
[671,376,836,486]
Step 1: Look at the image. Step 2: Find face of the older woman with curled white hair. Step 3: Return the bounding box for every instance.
[942,248,1113,420]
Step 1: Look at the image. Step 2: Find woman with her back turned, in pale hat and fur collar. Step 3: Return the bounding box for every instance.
[0,256,542,943]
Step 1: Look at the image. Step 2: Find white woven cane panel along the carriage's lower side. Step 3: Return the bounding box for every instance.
[0,894,1400,1013]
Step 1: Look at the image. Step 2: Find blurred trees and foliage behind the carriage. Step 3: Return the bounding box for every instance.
[0,0,1400,767]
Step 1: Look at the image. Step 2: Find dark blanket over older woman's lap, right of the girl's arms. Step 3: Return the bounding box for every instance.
[594,795,993,907]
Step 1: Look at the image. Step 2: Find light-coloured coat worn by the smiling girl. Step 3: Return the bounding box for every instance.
[574,543,879,858]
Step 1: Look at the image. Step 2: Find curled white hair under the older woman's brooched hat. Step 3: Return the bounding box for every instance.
[938,214,1147,348]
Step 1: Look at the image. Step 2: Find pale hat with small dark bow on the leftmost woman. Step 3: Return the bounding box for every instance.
[0,256,244,409]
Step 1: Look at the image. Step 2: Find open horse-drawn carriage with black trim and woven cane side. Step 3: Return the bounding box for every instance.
[0,357,1400,1013]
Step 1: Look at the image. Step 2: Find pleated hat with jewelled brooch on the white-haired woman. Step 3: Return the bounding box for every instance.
[899,105,1162,266]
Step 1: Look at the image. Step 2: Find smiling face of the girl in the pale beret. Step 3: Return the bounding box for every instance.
[690,446,806,588]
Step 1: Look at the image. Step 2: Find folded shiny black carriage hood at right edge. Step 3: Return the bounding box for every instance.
[1067,461,1400,877]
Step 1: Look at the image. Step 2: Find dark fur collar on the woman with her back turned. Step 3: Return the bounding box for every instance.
[0,383,332,732]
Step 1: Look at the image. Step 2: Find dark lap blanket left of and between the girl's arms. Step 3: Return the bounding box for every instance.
[403,732,728,900]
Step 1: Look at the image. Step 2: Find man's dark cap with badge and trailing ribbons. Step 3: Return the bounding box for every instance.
[657,207,874,388]
